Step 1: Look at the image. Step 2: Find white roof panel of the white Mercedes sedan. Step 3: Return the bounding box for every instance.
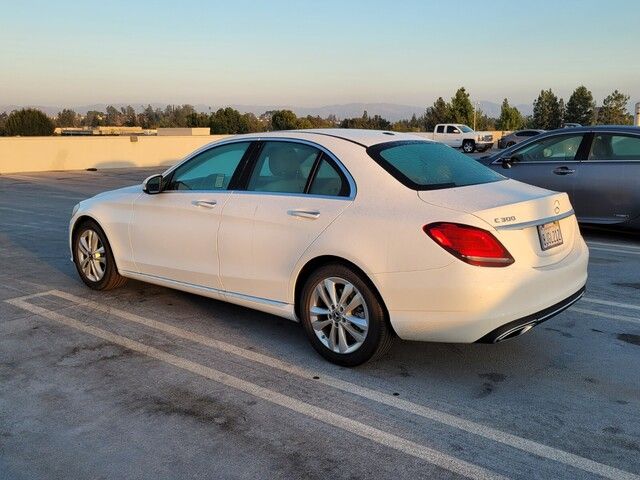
[215,128,431,148]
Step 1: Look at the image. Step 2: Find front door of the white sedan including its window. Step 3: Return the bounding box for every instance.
[129,141,251,290]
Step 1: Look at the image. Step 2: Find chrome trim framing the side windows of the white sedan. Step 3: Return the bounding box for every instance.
[161,136,358,200]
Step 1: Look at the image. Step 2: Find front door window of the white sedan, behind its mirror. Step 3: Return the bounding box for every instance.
[165,142,250,190]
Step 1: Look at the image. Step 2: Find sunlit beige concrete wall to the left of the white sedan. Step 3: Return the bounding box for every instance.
[0,135,228,174]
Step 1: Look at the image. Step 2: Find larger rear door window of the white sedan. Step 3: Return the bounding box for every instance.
[247,142,320,193]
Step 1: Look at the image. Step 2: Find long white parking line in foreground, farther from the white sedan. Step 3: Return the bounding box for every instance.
[6,299,504,480]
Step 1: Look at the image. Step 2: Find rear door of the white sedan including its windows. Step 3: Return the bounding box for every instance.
[219,140,355,303]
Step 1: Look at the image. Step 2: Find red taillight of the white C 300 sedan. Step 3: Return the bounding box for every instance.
[422,222,515,267]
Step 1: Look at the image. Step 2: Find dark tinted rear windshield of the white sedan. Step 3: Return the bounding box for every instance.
[367,140,505,190]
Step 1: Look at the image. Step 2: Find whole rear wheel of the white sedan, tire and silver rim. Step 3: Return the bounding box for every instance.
[300,264,393,367]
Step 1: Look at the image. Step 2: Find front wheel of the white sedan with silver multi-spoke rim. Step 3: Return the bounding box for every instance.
[73,220,127,290]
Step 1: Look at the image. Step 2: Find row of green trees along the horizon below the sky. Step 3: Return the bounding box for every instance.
[0,85,633,136]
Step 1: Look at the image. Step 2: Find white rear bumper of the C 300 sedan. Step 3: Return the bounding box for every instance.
[376,237,589,343]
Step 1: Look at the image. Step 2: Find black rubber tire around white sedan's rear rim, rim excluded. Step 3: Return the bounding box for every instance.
[299,263,394,367]
